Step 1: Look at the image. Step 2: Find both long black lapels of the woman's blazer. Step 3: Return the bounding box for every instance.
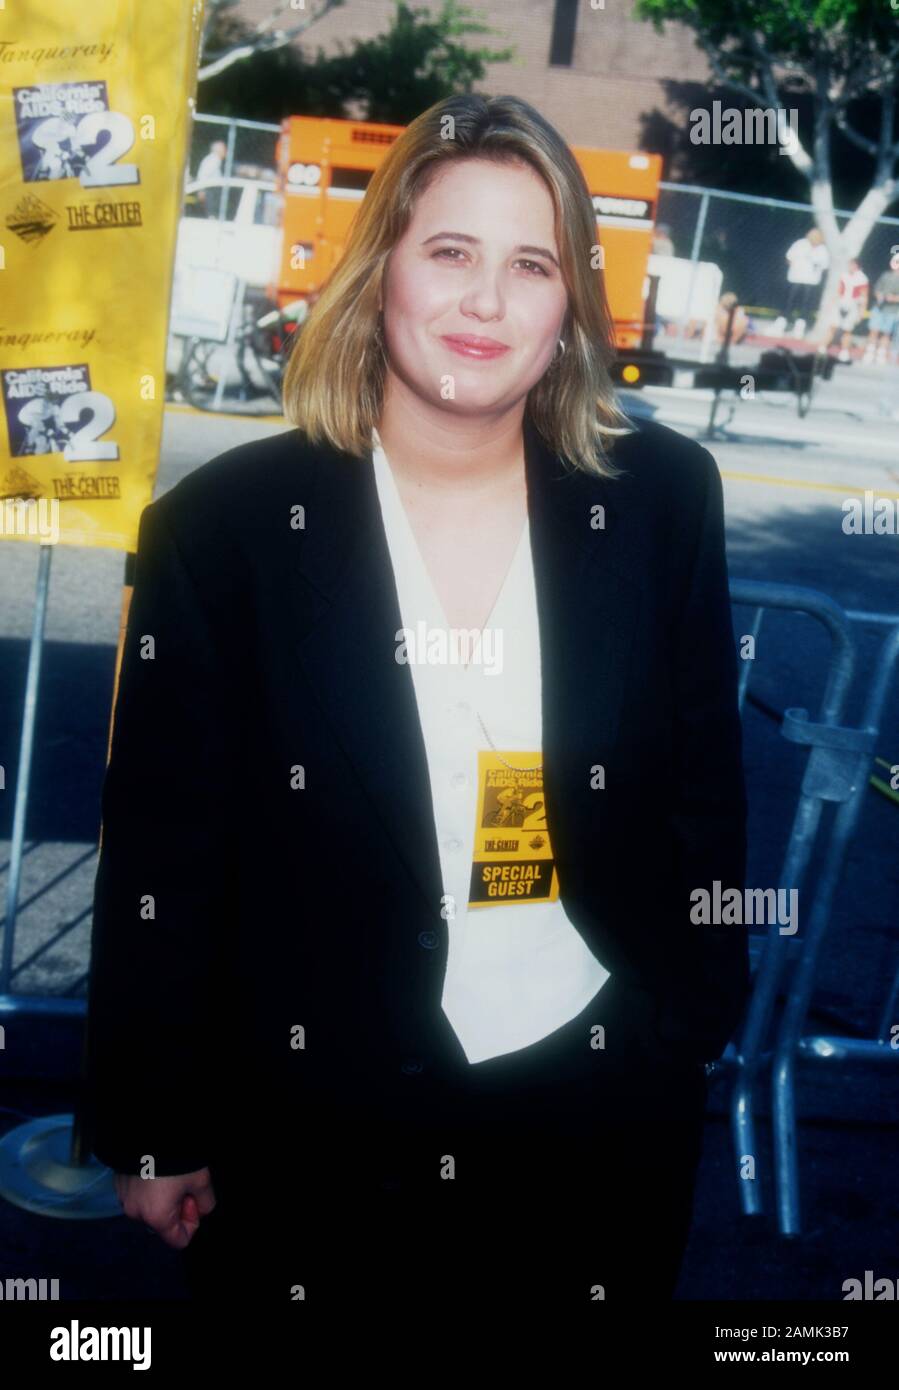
[289,420,639,919]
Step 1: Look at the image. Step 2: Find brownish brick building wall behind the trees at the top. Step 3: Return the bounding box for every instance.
[226,0,710,150]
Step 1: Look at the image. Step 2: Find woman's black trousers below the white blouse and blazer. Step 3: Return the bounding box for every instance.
[185,980,706,1315]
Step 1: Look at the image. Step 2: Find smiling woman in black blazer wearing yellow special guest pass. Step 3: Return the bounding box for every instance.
[89,96,748,1312]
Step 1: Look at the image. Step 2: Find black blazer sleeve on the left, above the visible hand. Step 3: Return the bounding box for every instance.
[85,495,233,1176]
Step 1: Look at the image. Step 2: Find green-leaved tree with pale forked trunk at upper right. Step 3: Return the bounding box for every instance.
[636,0,899,336]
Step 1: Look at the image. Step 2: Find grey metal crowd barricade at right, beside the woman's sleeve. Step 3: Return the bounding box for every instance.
[723,580,899,1236]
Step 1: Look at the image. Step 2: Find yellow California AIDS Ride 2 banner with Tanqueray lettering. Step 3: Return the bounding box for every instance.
[0,0,203,550]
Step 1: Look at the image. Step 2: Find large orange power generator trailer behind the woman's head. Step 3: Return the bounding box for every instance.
[268,115,661,385]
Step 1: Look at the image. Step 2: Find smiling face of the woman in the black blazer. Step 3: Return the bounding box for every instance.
[383,158,568,413]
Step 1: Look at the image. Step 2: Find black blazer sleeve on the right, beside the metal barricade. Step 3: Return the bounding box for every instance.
[657,449,750,1061]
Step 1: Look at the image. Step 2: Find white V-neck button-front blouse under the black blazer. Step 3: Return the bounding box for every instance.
[372,431,610,1062]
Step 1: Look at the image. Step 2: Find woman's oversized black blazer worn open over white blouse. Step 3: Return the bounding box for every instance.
[86,421,749,1175]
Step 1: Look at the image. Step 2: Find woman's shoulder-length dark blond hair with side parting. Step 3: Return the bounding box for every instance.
[283,93,631,478]
